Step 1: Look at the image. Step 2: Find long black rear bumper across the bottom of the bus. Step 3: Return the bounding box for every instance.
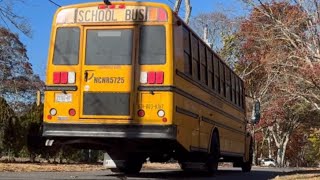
[43,123,177,140]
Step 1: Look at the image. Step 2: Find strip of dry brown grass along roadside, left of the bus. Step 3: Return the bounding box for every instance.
[0,163,104,172]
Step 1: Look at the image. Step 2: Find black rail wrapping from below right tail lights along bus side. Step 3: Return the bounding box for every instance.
[138,86,245,123]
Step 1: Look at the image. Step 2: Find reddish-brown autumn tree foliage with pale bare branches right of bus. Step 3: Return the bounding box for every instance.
[231,0,320,166]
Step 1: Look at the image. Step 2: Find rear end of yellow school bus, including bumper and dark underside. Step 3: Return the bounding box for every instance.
[43,2,177,172]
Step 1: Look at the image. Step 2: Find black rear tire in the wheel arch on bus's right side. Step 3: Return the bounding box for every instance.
[206,131,220,175]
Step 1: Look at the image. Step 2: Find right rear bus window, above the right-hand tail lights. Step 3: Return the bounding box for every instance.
[140,26,166,65]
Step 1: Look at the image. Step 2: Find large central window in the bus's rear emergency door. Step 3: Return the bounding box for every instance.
[86,29,133,65]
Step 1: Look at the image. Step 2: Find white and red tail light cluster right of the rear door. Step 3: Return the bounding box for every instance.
[140,71,164,84]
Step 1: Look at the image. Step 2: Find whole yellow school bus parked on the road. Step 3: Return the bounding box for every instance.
[43,1,253,173]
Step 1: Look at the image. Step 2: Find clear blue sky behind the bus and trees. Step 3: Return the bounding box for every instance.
[13,0,242,80]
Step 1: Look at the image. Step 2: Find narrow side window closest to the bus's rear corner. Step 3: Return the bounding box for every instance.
[183,27,192,75]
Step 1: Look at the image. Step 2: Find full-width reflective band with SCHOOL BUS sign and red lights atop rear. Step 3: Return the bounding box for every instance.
[56,5,168,24]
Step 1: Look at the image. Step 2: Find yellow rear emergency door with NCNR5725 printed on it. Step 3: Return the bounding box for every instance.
[81,27,135,120]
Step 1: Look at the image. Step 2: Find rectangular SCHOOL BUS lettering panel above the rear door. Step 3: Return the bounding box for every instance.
[76,6,147,23]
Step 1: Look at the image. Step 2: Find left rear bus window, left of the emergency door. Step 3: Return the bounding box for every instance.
[53,27,80,65]
